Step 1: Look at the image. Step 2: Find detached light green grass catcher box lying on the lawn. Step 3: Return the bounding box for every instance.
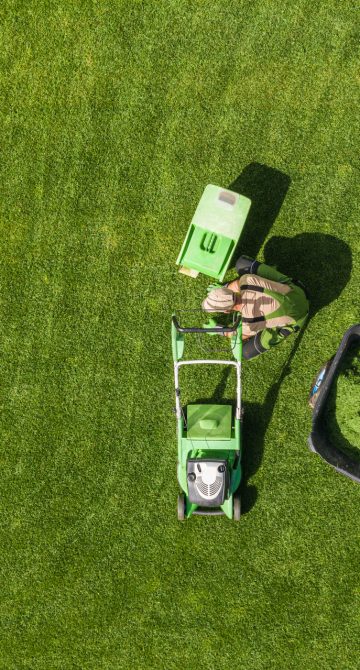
[176,184,251,282]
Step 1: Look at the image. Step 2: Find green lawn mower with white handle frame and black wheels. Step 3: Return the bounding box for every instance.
[171,314,242,521]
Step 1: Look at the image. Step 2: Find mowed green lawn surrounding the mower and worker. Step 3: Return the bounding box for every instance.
[0,0,360,670]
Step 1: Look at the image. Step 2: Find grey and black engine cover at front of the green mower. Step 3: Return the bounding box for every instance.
[186,458,230,507]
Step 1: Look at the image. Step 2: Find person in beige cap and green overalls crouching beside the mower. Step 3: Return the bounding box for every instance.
[202,256,309,359]
